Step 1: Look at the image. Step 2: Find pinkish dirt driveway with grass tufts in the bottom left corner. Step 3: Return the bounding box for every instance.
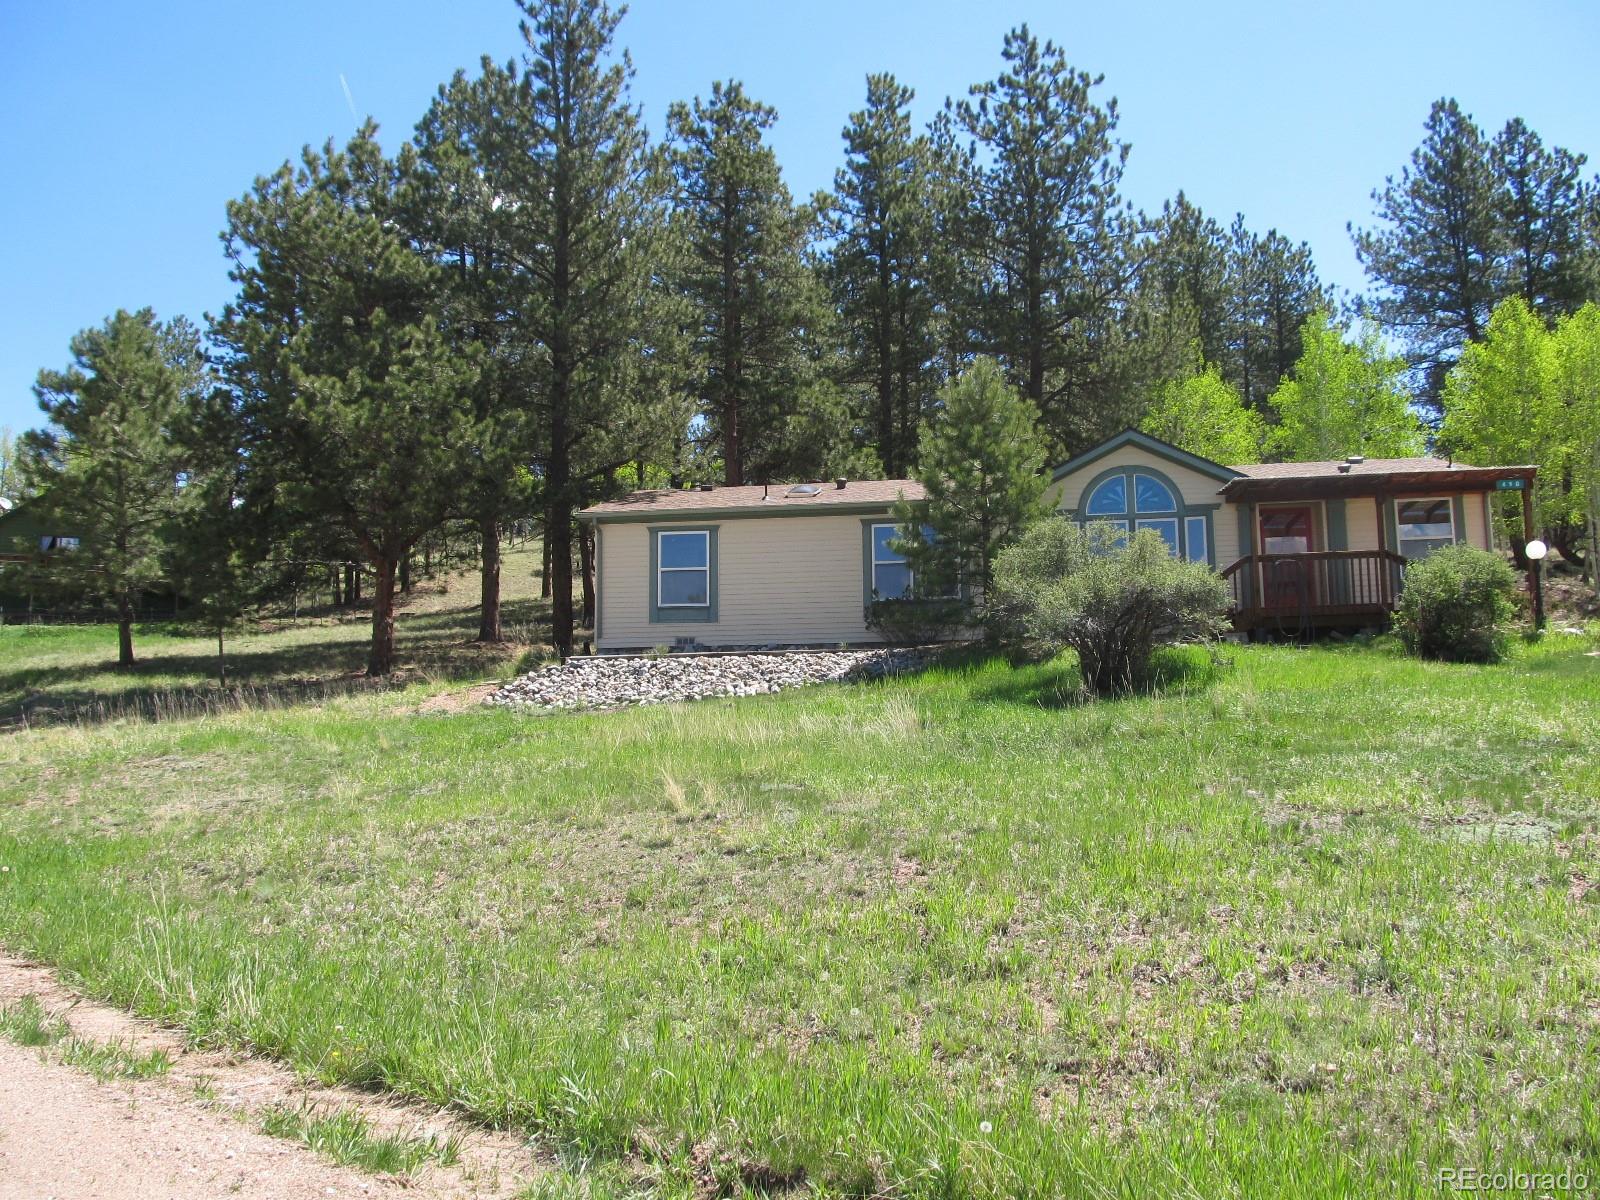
[0,955,539,1200]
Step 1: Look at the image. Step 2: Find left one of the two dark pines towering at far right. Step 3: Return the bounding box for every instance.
[1352,99,1506,402]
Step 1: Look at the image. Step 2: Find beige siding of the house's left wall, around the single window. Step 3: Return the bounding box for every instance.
[598,514,890,651]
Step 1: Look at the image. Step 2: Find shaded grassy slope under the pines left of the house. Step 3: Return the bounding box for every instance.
[0,542,549,726]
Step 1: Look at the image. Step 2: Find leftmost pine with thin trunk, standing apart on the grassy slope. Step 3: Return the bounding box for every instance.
[22,309,206,667]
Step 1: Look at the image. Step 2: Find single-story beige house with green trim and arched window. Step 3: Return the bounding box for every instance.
[581,430,1534,653]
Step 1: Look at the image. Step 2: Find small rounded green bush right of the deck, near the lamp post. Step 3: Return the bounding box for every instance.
[1395,546,1517,662]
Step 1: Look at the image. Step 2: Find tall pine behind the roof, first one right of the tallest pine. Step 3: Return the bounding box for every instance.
[667,80,824,485]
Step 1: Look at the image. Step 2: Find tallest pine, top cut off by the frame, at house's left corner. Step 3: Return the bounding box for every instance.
[504,0,670,656]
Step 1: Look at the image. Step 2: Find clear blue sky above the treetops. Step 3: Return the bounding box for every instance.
[0,0,1600,429]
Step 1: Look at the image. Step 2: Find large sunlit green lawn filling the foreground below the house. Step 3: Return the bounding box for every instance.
[0,635,1600,1197]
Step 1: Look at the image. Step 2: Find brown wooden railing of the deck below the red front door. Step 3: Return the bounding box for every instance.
[1222,550,1405,619]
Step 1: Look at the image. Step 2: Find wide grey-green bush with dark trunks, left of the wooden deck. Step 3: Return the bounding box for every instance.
[995,517,1227,696]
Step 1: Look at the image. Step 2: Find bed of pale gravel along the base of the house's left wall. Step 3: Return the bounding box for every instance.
[485,646,931,709]
